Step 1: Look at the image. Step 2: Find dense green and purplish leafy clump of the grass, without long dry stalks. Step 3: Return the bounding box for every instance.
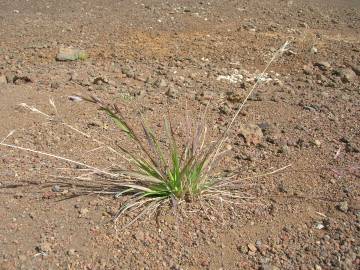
[77,96,221,221]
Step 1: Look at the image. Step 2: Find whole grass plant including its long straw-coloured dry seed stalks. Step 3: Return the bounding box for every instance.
[0,42,288,225]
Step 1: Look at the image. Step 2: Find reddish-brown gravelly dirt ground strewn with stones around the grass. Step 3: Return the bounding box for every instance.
[0,0,360,270]
